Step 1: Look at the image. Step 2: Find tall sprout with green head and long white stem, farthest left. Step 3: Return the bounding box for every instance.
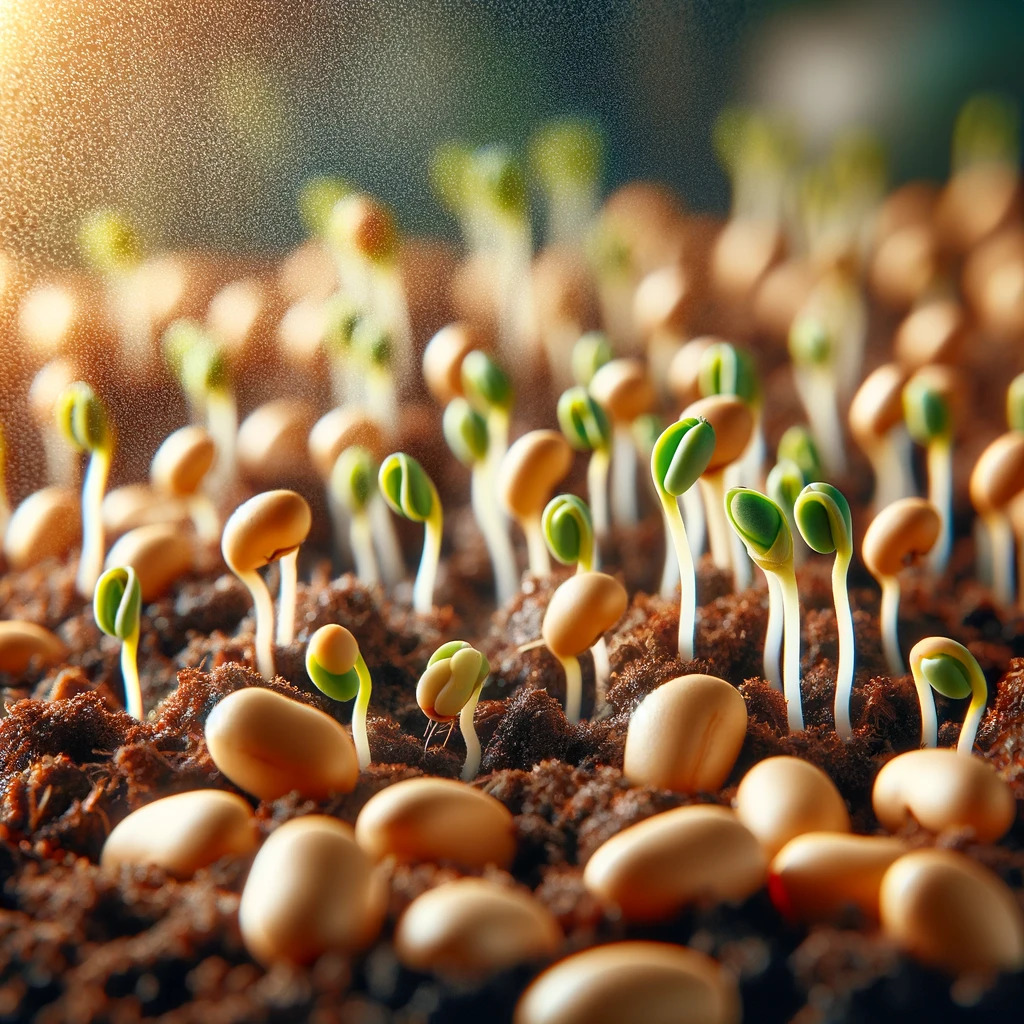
[54,381,114,597]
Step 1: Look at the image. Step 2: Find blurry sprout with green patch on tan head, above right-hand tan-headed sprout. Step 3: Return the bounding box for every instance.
[903,366,957,574]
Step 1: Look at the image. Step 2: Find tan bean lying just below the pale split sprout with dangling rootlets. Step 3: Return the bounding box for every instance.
[355,778,516,869]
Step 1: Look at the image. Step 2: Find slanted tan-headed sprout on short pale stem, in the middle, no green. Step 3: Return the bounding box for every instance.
[498,430,572,577]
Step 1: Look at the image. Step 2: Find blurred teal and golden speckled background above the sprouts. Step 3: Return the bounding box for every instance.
[0,0,1024,264]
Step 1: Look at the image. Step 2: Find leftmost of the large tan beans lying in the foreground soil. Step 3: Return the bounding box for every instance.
[100,790,257,879]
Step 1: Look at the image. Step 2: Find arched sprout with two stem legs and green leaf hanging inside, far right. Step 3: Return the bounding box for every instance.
[910,637,988,757]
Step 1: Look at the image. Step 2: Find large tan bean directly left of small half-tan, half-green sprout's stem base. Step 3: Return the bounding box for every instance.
[206,686,359,800]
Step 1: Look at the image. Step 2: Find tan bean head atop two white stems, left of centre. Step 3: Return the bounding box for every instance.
[221,490,312,572]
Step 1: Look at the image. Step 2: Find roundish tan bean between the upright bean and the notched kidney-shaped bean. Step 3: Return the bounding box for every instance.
[733,757,850,857]
